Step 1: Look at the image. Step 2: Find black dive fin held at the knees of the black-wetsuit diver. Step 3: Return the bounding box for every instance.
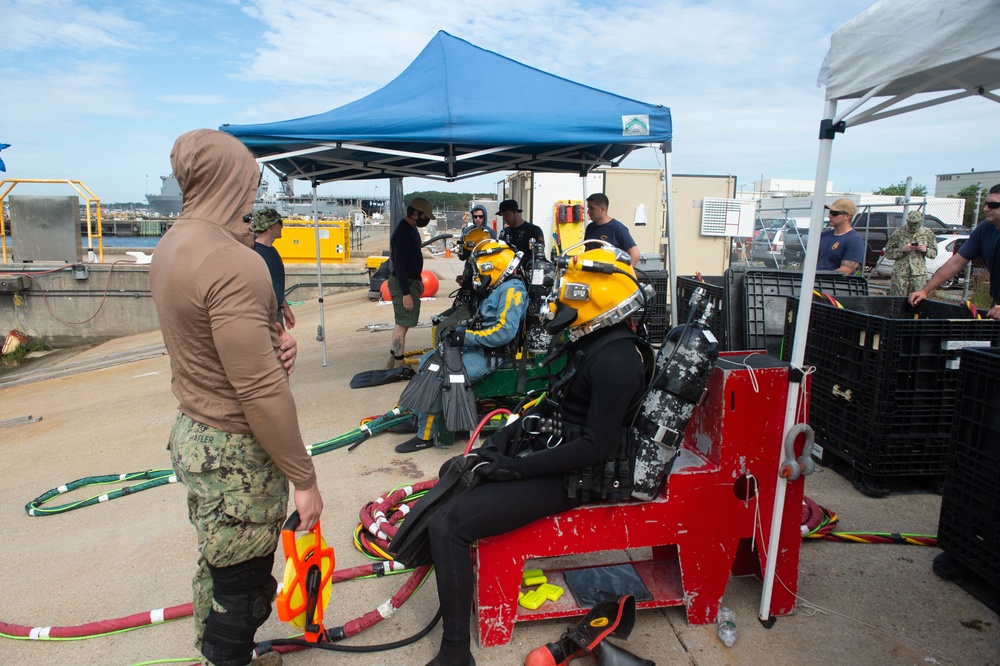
[388,456,479,568]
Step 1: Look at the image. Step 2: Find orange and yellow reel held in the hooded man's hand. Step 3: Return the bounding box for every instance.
[275,511,336,643]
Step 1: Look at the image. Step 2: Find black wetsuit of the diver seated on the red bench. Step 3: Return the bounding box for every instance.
[428,324,644,646]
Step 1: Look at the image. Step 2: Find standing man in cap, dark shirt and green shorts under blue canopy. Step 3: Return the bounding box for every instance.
[386,197,435,370]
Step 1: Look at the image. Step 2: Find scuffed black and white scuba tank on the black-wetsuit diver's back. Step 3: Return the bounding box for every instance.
[629,287,719,501]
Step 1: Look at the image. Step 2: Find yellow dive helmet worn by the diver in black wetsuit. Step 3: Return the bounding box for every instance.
[542,241,647,340]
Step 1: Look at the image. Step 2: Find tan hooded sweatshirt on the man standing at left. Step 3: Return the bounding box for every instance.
[149,130,316,490]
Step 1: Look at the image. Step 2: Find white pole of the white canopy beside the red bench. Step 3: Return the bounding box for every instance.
[758,100,837,622]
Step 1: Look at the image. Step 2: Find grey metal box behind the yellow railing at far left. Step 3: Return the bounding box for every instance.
[8,195,83,263]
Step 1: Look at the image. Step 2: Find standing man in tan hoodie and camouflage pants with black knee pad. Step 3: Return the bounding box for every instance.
[149,130,323,666]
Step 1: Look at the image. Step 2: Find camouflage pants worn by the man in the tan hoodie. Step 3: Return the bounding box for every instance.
[169,414,288,649]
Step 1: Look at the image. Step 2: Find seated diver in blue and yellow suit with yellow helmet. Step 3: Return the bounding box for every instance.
[396,240,528,453]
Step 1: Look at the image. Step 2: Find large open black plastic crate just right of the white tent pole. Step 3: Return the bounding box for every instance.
[783,297,1000,478]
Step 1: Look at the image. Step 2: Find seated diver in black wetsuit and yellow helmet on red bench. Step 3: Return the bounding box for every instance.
[389,247,680,666]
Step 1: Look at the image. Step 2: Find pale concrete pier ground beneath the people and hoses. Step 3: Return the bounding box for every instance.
[0,252,1000,666]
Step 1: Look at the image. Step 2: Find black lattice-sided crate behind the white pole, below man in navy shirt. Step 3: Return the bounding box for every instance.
[744,270,868,356]
